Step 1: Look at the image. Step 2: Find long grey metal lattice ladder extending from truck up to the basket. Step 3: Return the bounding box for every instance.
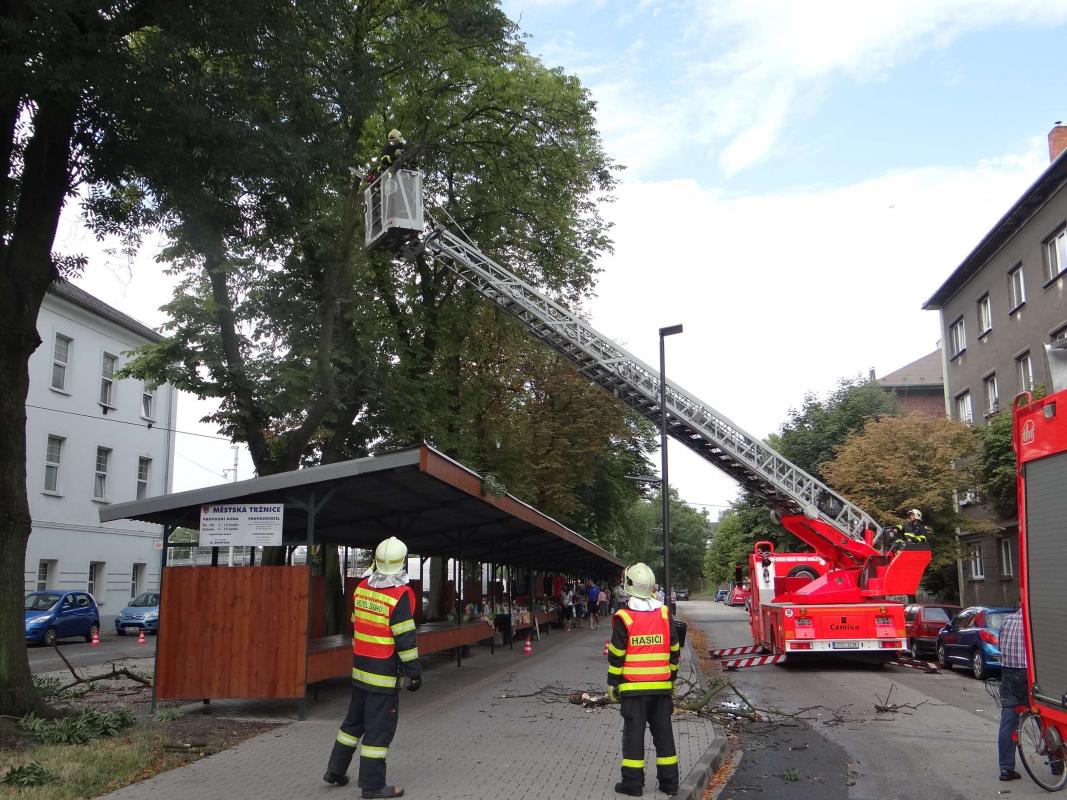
[418,222,880,542]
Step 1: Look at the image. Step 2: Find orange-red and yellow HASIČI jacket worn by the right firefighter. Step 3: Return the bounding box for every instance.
[607,606,680,694]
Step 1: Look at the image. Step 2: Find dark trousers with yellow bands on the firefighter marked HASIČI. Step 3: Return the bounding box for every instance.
[619,694,678,791]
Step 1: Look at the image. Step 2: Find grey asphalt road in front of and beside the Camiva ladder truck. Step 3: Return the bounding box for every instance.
[679,601,1047,800]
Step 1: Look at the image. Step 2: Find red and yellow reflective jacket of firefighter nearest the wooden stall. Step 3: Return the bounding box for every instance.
[352,580,423,693]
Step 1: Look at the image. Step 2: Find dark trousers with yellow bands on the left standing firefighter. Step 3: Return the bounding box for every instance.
[327,686,400,789]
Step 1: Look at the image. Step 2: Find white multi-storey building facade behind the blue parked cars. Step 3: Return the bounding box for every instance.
[26,282,177,630]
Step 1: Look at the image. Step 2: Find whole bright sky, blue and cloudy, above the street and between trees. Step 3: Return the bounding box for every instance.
[70,0,1067,507]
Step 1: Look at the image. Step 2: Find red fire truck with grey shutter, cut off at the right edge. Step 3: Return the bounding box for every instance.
[1013,342,1067,791]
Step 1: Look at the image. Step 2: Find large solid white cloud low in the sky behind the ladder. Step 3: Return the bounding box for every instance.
[591,140,1048,502]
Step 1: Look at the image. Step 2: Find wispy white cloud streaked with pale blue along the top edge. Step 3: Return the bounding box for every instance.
[687,0,1067,174]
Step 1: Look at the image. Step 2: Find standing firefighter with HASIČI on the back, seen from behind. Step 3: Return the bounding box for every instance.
[607,563,680,797]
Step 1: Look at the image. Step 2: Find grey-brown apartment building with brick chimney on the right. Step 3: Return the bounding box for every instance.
[923,123,1067,606]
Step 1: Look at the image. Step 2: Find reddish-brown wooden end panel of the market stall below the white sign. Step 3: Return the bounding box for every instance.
[156,566,308,700]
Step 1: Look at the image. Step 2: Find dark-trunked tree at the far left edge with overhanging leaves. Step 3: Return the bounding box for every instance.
[0,0,324,714]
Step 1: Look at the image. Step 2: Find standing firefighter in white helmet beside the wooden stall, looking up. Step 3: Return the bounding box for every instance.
[322,537,423,798]
